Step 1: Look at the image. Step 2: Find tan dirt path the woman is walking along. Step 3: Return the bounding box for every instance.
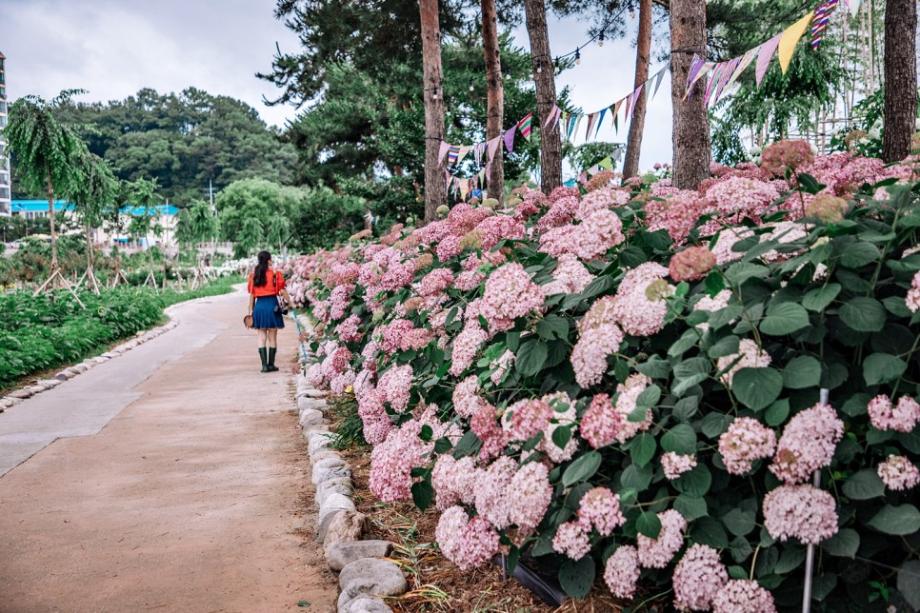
[0,294,336,613]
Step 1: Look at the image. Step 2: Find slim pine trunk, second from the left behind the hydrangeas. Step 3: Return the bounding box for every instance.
[482,0,504,203]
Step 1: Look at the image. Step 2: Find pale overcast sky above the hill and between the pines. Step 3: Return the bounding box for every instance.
[0,0,671,168]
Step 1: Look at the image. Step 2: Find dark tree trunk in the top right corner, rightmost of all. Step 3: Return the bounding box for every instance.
[882,0,917,162]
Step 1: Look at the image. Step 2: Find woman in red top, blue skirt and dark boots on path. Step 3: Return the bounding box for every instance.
[249,251,291,372]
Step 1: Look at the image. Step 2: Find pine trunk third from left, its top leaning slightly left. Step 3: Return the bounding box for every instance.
[524,0,562,194]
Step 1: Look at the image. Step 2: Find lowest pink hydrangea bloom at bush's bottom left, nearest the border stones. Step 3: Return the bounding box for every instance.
[435,507,499,570]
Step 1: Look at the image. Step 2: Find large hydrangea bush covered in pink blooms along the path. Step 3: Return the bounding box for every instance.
[289,142,920,612]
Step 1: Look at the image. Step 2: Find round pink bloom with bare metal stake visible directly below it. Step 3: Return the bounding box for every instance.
[763,485,837,545]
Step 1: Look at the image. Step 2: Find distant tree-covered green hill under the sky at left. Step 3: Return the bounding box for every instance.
[16,88,297,203]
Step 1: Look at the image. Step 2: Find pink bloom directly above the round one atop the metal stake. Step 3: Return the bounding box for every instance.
[770,403,843,483]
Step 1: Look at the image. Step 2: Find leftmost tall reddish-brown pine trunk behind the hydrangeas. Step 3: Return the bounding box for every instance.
[419,0,446,223]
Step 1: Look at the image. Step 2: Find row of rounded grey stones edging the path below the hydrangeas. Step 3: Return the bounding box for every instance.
[294,315,408,613]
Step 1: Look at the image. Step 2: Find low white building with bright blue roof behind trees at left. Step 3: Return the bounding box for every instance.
[10,200,179,252]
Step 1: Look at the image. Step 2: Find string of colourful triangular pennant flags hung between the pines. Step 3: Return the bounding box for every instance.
[446,0,862,200]
